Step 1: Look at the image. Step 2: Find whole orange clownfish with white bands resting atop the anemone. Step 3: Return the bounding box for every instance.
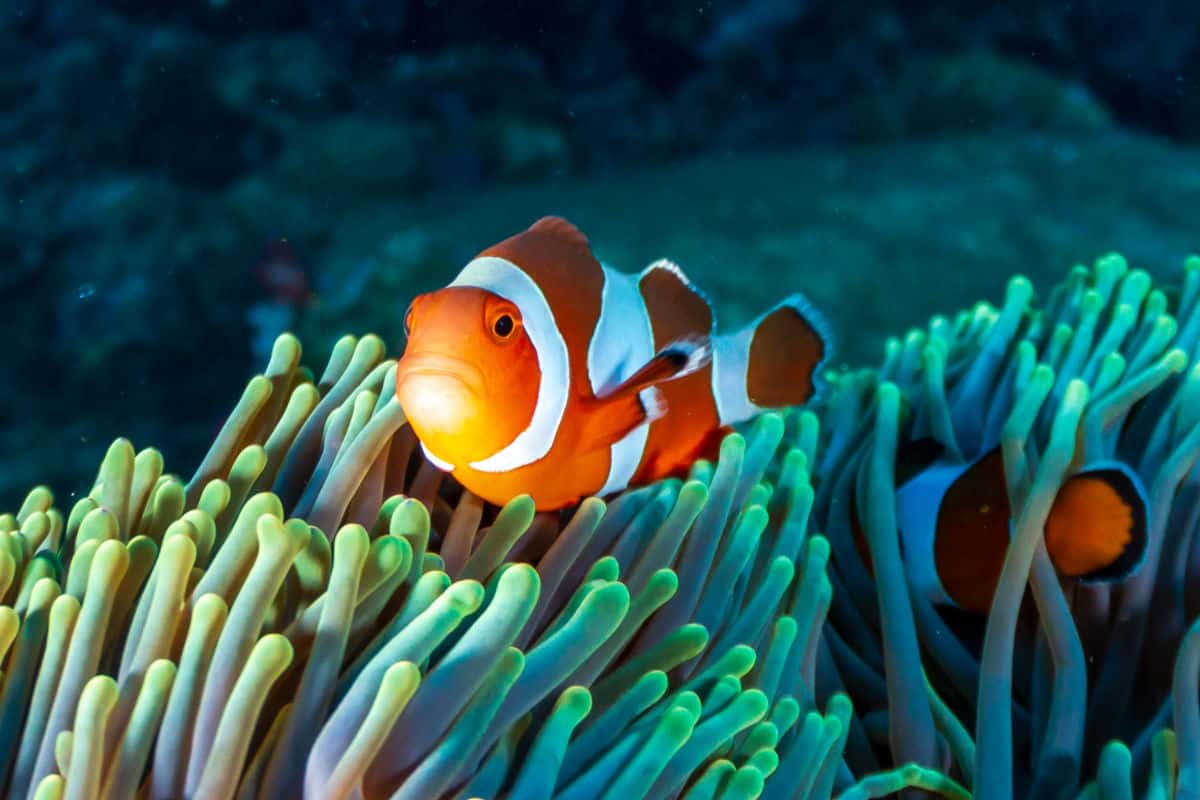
[396,217,830,510]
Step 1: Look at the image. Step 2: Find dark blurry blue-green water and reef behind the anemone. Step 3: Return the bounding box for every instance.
[0,0,1200,507]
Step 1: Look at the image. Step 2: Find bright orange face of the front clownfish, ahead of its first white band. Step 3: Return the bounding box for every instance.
[396,285,541,470]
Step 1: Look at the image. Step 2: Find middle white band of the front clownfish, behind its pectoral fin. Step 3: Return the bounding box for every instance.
[588,266,654,495]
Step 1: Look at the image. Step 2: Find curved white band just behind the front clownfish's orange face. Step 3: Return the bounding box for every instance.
[450,255,571,473]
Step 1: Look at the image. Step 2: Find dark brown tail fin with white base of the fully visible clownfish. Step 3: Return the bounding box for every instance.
[713,294,833,425]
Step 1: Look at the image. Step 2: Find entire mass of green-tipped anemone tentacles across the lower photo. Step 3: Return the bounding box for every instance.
[0,257,1200,800]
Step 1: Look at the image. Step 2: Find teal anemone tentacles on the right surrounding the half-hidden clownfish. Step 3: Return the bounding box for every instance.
[814,255,1200,799]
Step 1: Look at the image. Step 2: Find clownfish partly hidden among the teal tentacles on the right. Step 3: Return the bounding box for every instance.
[850,439,1150,614]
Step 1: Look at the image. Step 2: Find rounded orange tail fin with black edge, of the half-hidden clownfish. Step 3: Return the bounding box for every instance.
[1045,463,1148,583]
